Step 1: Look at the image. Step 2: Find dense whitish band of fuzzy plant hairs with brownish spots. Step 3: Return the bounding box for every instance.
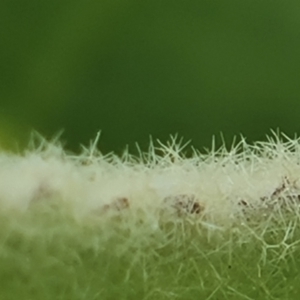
[0,132,300,229]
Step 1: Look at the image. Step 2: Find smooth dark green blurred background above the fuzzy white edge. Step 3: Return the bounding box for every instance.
[0,0,300,152]
